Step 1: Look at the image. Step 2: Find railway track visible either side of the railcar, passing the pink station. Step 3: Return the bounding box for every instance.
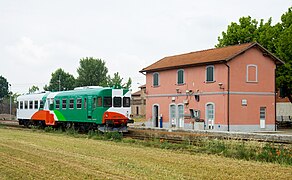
[0,120,292,145]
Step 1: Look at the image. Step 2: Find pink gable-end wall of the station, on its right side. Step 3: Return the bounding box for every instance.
[228,48,275,130]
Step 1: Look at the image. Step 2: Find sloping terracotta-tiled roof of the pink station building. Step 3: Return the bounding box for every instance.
[140,42,284,72]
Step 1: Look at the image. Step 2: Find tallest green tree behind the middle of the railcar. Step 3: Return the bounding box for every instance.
[76,57,108,86]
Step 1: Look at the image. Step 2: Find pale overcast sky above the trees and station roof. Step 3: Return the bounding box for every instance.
[0,0,292,93]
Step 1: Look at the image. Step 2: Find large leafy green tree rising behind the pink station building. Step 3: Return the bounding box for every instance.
[215,7,292,102]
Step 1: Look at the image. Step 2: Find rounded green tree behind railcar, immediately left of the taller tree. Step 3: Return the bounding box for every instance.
[44,68,75,91]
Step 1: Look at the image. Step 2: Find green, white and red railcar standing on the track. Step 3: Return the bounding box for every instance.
[17,87,133,132]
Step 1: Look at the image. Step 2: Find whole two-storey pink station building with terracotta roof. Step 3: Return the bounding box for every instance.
[140,43,283,132]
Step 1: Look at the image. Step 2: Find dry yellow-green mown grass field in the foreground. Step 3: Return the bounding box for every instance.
[0,128,292,179]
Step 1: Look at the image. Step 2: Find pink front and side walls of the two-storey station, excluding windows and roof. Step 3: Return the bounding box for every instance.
[146,48,275,131]
